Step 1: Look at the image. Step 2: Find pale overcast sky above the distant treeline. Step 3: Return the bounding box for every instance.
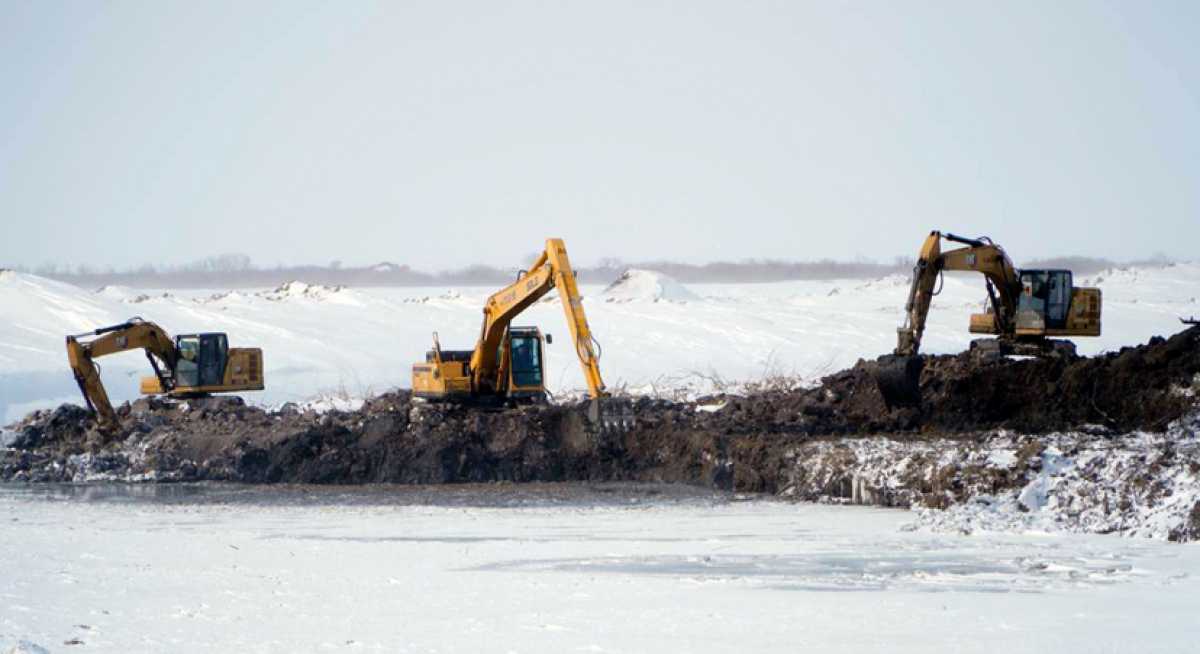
[0,0,1200,269]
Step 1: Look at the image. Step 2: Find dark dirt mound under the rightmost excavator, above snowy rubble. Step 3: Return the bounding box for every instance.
[706,328,1200,436]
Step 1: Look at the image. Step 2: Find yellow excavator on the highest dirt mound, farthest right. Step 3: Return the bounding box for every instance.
[878,232,1100,402]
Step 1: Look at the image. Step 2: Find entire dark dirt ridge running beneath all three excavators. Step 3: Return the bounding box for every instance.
[0,326,1200,492]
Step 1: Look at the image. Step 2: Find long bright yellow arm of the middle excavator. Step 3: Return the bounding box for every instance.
[470,239,608,398]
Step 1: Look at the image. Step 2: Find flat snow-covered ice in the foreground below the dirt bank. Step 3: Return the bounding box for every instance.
[0,486,1200,653]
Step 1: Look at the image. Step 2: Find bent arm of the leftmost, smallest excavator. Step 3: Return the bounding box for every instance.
[67,318,176,428]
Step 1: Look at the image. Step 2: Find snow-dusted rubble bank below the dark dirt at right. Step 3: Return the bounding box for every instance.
[781,412,1200,541]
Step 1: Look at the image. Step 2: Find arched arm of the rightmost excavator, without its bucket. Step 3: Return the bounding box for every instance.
[895,232,1020,356]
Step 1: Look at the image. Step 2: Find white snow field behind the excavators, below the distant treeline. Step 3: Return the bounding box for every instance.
[0,264,1200,424]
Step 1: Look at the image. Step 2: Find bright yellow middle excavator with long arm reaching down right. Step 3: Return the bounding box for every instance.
[413,239,631,427]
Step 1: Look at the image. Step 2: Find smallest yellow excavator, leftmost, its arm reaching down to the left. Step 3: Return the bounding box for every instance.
[67,317,263,431]
